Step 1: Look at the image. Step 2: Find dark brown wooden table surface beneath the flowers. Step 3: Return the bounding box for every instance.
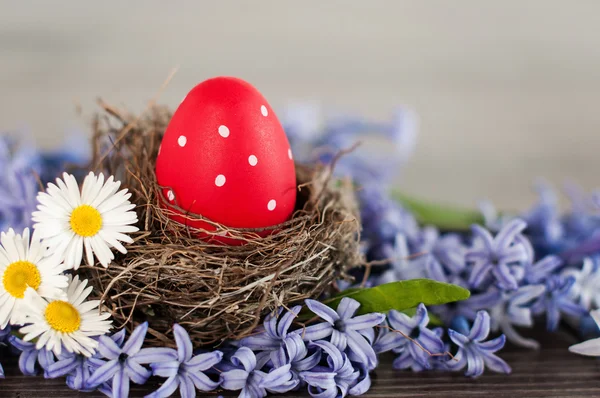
[0,326,600,398]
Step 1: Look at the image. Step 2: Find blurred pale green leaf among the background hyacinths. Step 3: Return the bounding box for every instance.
[392,191,484,231]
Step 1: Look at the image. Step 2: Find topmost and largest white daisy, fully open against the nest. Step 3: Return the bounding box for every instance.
[32,173,138,269]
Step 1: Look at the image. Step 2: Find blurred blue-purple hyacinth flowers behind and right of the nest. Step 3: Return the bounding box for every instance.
[284,108,600,348]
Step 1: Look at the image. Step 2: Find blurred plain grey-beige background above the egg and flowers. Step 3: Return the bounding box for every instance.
[0,0,600,209]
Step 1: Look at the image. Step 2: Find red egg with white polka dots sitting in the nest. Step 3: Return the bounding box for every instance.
[156,77,296,243]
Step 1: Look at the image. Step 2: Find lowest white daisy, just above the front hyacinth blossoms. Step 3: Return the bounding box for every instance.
[20,276,112,357]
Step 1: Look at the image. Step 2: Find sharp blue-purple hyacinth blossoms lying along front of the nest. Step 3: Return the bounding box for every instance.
[3,298,510,398]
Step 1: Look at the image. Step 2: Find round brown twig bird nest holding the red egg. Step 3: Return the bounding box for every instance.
[81,103,363,346]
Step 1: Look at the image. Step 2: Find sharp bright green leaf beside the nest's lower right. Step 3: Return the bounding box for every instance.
[324,279,471,315]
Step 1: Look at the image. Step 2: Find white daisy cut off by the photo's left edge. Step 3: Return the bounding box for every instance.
[0,229,68,329]
